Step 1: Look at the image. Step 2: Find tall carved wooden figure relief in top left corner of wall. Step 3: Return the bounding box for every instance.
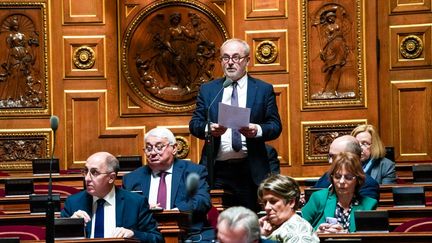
[0,2,49,116]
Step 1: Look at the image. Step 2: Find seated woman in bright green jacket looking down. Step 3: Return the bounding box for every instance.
[302,152,378,233]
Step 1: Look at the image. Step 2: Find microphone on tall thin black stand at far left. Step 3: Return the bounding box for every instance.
[45,115,59,243]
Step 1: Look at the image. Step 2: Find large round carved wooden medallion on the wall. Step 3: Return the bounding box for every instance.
[121,0,228,112]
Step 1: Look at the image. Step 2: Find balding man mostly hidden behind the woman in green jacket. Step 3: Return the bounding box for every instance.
[314,135,379,201]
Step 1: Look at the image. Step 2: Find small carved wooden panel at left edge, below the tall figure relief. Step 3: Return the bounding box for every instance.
[0,130,52,170]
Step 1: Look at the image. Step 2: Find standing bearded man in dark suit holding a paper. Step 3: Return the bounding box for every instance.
[189,39,282,211]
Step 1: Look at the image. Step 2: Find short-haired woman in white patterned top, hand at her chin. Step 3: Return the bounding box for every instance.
[258,174,319,243]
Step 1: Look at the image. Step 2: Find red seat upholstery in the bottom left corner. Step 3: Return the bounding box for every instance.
[0,225,45,240]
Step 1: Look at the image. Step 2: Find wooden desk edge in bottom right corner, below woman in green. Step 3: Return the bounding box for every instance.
[318,232,432,243]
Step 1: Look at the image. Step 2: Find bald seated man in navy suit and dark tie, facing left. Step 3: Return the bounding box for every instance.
[61,152,164,242]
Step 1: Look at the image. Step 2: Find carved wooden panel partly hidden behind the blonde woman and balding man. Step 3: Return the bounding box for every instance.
[302,120,366,164]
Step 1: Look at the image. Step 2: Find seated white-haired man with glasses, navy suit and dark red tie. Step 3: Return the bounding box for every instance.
[123,127,215,242]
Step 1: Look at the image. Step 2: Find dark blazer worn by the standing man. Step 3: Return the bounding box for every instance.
[189,76,282,185]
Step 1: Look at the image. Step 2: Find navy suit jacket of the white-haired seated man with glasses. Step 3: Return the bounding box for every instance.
[123,159,214,239]
